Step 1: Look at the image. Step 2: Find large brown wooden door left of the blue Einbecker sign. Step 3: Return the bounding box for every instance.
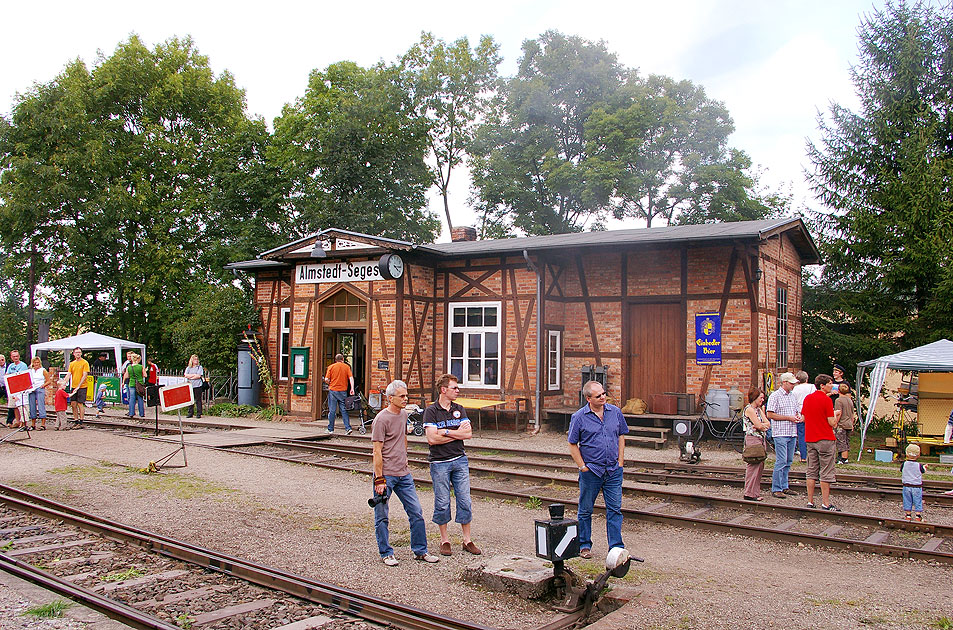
[626,303,685,402]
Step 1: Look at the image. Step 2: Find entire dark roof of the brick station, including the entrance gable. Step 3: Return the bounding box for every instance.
[226,217,821,270]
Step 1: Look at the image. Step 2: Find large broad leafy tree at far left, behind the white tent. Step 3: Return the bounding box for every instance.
[0,36,280,368]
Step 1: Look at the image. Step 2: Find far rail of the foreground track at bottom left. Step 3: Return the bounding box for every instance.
[0,484,491,630]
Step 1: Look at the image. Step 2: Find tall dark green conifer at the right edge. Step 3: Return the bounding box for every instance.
[805,2,953,348]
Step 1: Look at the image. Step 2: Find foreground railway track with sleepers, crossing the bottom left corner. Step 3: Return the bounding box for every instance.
[0,485,512,630]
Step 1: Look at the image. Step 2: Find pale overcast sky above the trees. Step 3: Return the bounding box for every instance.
[0,0,884,239]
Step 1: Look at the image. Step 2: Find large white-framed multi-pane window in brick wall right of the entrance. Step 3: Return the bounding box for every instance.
[448,302,501,388]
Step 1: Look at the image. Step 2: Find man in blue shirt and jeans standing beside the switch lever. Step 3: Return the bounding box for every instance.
[569,381,629,558]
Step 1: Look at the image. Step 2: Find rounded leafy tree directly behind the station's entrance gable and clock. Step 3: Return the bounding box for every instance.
[269,62,439,242]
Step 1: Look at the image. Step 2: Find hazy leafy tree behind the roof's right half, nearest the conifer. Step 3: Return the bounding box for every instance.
[586,72,750,227]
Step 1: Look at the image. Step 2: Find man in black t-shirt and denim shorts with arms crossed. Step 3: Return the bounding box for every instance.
[424,374,481,556]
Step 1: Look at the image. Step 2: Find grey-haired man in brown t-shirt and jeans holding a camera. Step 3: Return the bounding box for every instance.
[367,381,440,567]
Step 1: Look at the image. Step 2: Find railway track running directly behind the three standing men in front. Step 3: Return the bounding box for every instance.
[24,420,953,564]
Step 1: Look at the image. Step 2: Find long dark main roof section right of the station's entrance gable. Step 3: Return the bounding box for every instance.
[417,218,820,265]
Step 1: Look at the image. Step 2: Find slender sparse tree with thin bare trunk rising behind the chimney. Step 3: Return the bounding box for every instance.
[401,32,501,235]
